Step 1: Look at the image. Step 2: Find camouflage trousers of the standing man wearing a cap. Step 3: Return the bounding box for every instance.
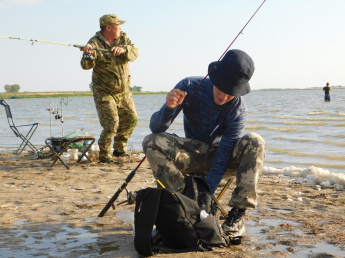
[93,90,138,158]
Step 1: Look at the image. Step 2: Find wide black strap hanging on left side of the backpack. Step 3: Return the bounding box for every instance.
[134,188,162,256]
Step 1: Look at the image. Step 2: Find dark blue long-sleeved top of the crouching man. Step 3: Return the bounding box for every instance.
[150,77,247,193]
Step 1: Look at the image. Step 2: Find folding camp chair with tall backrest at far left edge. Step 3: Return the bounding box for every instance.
[0,99,39,155]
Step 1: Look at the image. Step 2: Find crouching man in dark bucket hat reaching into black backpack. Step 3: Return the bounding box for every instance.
[143,50,265,236]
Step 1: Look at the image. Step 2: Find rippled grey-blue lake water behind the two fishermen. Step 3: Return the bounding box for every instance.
[0,89,345,174]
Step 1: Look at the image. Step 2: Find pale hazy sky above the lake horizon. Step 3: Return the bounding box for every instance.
[0,0,345,92]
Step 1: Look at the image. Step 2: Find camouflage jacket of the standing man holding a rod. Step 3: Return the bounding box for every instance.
[81,31,138,94]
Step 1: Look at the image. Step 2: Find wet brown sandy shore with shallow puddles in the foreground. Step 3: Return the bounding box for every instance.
[0,152,345,257]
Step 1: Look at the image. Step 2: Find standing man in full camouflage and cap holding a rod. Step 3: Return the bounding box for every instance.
[81,14,138,163]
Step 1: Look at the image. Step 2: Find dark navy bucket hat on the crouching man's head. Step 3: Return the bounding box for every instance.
[208,49,255,96]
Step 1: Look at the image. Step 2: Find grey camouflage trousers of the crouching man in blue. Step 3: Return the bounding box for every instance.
[143,133,265,208]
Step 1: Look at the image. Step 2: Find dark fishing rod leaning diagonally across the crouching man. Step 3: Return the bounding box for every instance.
[98,0,266,217]
